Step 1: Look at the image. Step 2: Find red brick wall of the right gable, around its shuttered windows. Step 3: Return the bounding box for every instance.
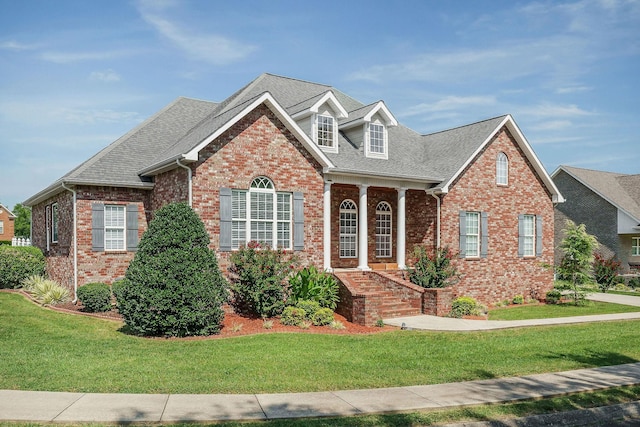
[441,129,554,304]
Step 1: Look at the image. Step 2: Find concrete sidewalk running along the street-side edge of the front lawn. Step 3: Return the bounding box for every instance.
[0,362,640,423]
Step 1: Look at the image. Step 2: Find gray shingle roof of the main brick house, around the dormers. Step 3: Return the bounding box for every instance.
[25,74,553,204]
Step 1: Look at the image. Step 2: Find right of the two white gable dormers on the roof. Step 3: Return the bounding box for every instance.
[340,101,398,159]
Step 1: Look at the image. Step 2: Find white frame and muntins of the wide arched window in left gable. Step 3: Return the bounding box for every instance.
[231,177,293,250]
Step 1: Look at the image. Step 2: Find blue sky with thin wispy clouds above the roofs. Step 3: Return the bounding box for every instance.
[0,0,640,208]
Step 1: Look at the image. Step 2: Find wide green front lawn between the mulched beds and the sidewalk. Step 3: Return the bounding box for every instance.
[0,293,640,393]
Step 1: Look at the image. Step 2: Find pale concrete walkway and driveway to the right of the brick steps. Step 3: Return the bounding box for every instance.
[384,293,640,331]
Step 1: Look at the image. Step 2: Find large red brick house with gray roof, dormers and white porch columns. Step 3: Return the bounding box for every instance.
[25,74,562,323]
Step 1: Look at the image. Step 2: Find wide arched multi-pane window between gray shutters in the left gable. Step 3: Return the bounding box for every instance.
[231,176,291,249]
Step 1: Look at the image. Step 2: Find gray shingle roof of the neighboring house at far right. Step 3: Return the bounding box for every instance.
[559,166,640,222]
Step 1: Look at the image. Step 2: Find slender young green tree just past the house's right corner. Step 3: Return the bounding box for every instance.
[558,220,598,305]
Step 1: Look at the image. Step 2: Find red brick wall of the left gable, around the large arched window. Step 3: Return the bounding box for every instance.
[192,106,324,271]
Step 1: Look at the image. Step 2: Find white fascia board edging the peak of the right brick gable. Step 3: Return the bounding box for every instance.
[441,114,564,203]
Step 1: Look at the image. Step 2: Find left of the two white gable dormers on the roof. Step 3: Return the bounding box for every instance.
[291,91,348,153]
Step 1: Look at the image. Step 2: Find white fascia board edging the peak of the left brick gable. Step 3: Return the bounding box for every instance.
[183,92,334,168]
